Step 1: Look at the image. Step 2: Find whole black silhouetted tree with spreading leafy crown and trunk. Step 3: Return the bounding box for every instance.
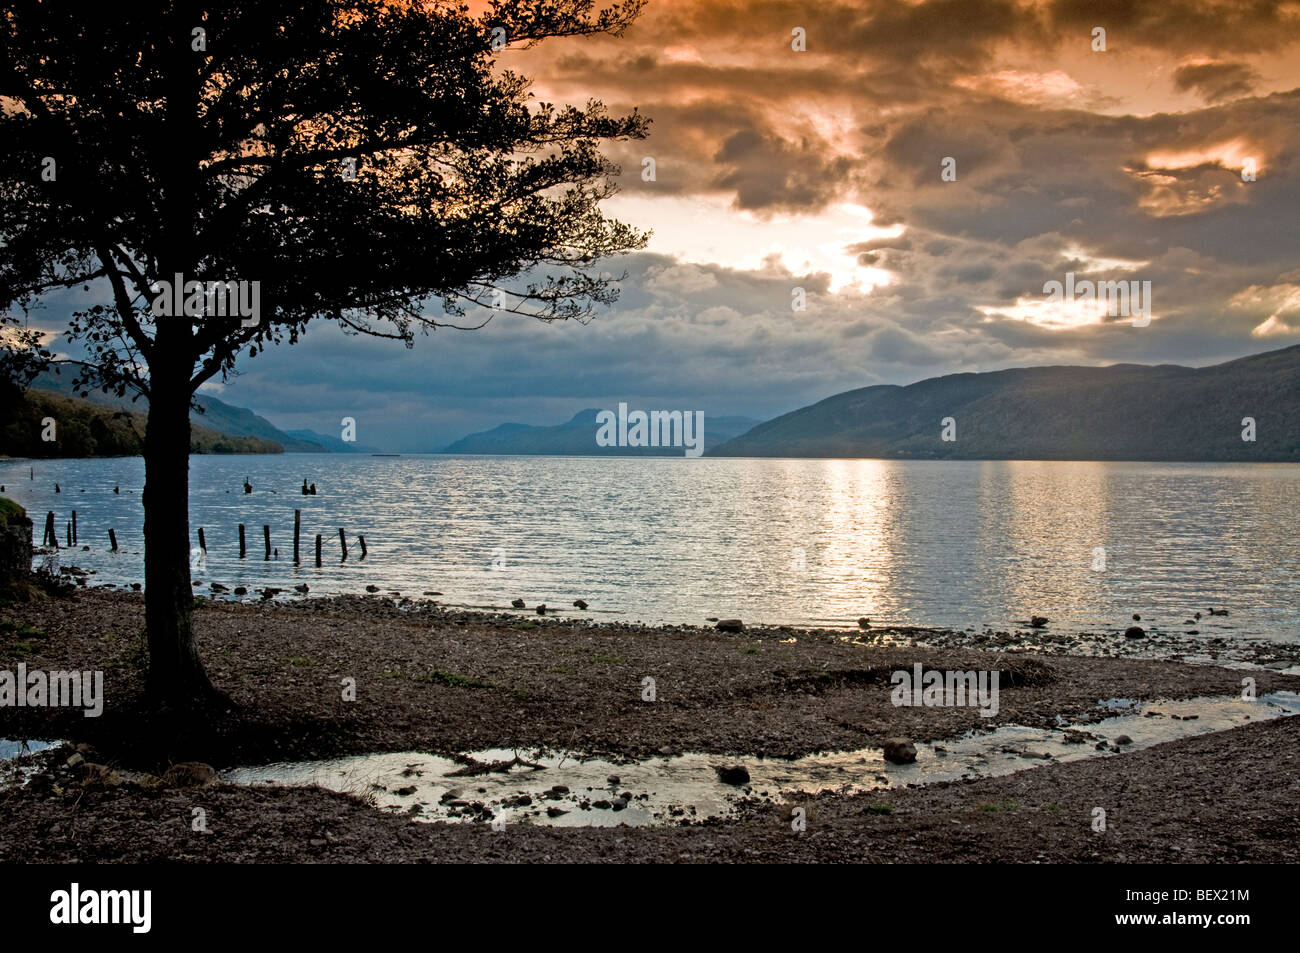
[0,0,646,706]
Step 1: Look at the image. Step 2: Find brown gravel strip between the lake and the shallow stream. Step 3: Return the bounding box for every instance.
[0,589,1300,768]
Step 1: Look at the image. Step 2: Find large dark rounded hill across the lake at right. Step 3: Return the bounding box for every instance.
[706,346,1300,462]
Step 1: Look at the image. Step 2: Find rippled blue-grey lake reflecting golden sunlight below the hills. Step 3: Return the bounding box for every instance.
[0,454,1300,641]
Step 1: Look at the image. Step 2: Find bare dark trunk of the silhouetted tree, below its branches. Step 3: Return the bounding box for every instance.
[144,371,220,709]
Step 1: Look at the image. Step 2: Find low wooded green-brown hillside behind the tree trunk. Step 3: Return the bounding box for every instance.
[0,389,282,458]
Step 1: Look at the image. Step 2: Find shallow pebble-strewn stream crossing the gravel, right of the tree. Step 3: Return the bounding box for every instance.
[221,692,1300,827]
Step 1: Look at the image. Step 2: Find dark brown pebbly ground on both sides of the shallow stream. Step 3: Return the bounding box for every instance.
[0,592,1300,863]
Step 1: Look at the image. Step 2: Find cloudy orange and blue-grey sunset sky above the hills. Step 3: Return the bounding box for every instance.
[40,0,1300,450]
